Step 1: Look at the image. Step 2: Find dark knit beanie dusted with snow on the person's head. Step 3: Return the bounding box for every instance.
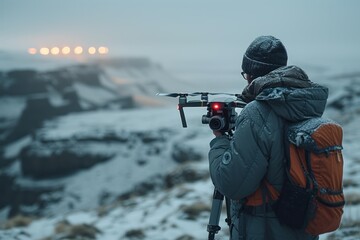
[242,36,287,77]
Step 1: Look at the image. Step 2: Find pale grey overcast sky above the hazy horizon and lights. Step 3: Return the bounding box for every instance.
[0,0,360,70]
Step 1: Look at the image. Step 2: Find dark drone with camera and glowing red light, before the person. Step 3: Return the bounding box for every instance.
[156,92,246,133]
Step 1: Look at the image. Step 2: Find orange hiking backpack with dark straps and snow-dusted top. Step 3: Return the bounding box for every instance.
[248,118,345,235]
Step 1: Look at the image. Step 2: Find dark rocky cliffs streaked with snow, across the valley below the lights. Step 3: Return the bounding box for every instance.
[0,59,183,216]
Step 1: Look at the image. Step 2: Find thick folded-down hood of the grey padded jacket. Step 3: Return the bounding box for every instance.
[242,66,328,122]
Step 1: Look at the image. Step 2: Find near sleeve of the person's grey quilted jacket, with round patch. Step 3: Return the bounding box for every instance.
[209,104,271,200]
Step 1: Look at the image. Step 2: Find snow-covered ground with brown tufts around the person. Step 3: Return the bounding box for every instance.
[0,54,360,240]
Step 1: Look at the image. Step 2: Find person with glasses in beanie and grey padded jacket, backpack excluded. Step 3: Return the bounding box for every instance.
[209,36,328,240]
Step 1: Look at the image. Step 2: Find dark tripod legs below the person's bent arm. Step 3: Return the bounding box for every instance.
[207,189,231,240]
